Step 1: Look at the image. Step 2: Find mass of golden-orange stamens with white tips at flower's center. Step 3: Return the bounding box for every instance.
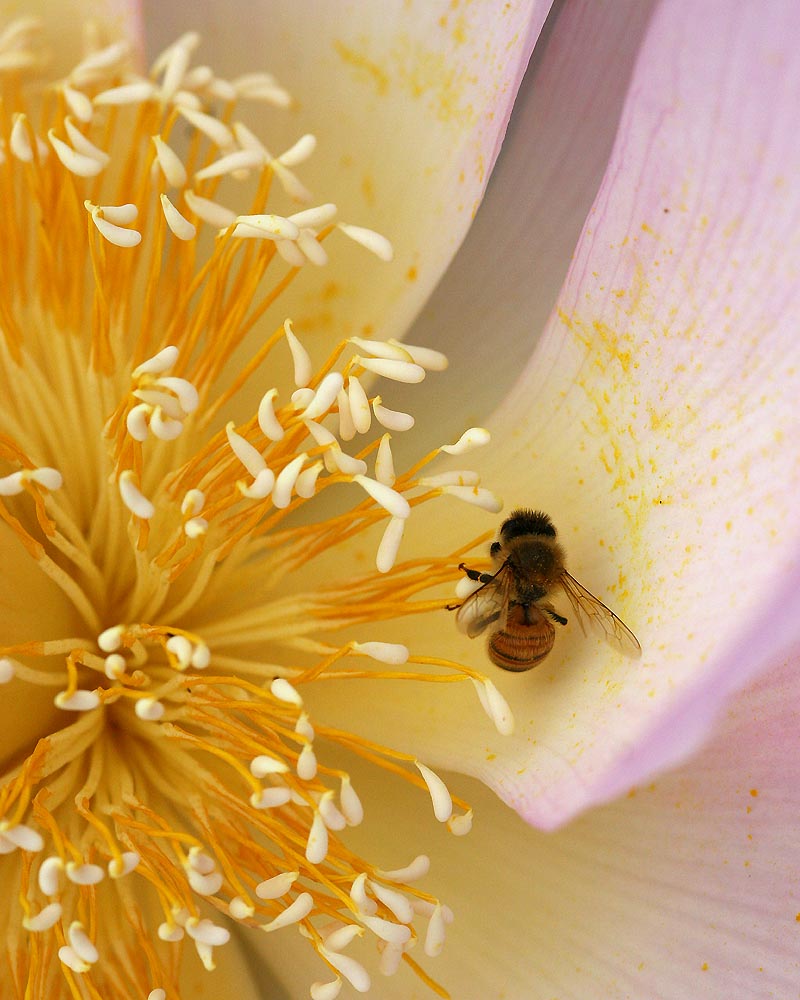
[0,21,511,1000]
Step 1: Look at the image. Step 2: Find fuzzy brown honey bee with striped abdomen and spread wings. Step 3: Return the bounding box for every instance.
[456,510,642,671]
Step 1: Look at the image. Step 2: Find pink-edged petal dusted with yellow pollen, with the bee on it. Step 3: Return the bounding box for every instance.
[462,2,800,825]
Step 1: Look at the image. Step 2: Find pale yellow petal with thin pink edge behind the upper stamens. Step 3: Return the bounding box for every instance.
[146,0,551,340]
